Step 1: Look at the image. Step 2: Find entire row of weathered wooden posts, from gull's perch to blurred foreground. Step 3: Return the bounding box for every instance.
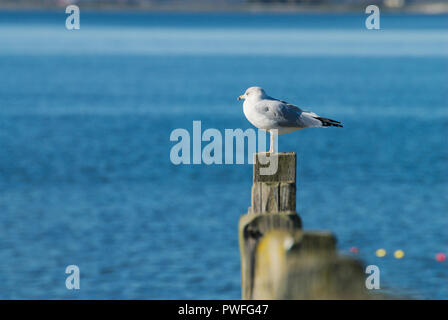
[239,153,366,299]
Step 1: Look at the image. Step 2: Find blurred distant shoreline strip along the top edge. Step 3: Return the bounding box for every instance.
[0,0,448,14]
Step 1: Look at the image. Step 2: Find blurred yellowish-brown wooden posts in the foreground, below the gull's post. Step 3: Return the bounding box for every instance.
[252,230,368,300]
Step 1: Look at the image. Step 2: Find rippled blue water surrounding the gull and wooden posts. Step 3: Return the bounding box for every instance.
[0,10,448,299]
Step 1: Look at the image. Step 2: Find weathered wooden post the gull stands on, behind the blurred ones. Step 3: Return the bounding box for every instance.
[239,153,302,299]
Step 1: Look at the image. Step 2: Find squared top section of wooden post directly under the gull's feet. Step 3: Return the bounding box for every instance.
[254,152,297,183]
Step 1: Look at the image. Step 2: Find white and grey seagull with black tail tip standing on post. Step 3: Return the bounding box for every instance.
[237,87,342,153]
